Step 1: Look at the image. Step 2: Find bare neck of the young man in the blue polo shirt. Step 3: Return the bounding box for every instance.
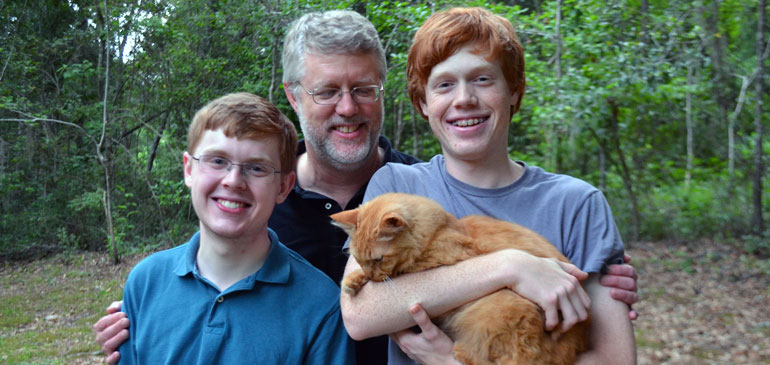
[196,227,270,291]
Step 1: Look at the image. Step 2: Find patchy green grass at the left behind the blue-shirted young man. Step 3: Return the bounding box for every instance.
[0,253,136,364]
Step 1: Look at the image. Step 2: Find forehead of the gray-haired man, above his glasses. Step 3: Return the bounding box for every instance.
[302,53,381,87]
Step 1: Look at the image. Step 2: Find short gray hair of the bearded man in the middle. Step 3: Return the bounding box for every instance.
[282,10,387,88]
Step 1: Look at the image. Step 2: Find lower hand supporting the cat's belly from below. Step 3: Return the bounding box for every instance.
[390,304,460,365]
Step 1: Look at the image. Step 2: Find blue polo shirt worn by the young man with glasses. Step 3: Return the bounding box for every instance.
[120,230,354,364]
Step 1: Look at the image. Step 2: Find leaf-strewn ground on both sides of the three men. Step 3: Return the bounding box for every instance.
[0,241,770,364]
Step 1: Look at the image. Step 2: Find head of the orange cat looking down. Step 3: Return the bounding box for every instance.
[331,193,445,281]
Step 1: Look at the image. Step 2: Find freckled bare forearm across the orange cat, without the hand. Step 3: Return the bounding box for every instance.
[340,251,519,340]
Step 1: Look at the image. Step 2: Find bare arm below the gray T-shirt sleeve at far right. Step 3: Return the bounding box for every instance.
[576,274,636,364]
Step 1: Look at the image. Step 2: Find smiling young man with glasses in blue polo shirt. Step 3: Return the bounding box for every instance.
[120,93,354,364]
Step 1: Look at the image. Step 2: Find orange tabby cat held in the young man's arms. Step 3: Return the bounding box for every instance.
[331,193,588,364]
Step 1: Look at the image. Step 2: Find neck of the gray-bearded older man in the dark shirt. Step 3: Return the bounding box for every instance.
[297,147,385,209]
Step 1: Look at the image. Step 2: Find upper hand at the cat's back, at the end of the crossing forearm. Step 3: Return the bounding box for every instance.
[506,251,591,333]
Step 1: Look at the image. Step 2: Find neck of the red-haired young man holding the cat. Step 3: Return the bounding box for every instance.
[444,152,524,189]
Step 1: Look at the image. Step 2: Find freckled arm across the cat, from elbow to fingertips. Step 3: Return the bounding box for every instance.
[340,250,590,340]
